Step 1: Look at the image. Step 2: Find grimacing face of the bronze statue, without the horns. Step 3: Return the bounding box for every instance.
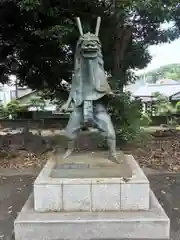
[80,33,100,58]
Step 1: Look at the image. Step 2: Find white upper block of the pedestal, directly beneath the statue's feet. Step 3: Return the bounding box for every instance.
[34,153,150,212]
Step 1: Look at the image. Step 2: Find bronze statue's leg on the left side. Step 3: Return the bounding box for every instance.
[64,107,83,158]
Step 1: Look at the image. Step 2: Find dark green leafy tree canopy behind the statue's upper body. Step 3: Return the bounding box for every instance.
[0,0,180,97]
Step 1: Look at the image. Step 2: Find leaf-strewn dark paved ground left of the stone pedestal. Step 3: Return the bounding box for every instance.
[0,175,34,240]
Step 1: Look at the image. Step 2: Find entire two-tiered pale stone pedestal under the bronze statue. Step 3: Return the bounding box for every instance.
[14,153,170,240]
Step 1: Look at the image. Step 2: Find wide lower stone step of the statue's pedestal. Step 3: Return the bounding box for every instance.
[14,192,170,240]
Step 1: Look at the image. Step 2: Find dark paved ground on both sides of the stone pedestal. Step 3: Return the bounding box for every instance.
[0,173,180,240]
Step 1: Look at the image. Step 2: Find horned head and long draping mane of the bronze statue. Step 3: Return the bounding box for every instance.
[71,17,111,103]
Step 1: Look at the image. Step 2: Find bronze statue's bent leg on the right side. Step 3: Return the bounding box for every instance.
[94,103,119,163]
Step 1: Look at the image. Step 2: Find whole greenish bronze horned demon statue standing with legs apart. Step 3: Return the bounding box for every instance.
[60,17,118,163]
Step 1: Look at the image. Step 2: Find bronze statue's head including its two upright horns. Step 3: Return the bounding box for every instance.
[77,17,101,58]
